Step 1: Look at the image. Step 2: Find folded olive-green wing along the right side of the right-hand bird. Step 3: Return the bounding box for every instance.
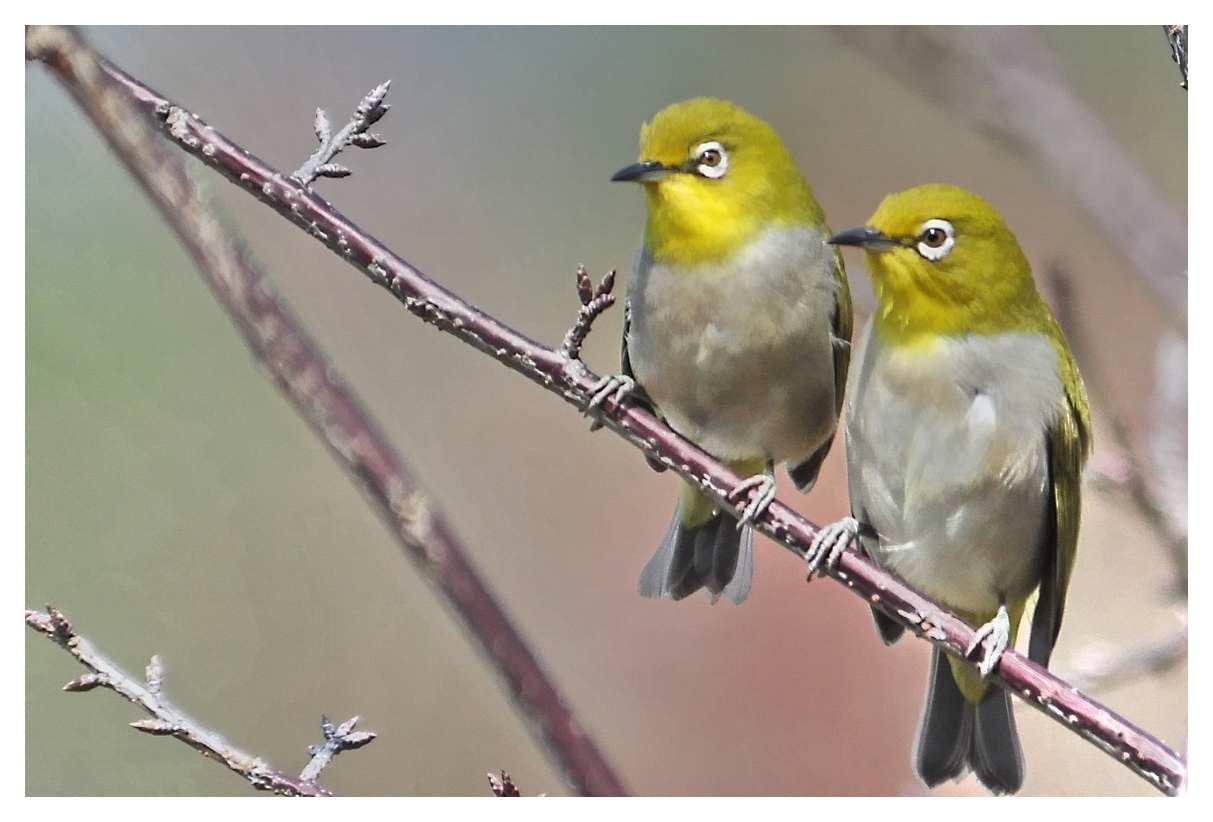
[1027,368,1090,667]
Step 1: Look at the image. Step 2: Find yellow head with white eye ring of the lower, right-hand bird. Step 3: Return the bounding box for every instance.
[830,183,1060,344]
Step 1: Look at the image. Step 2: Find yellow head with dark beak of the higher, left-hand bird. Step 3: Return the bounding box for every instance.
[611,97,825,267]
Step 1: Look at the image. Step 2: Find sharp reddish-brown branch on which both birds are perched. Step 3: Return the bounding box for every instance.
[26,27,1186,794]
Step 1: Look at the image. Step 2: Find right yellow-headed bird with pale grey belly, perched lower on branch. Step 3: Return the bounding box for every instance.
[808,184,1090,794]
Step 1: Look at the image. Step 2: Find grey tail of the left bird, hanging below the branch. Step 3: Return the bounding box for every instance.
[637,501,754,605]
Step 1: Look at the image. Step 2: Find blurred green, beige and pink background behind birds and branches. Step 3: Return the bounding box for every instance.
[25,25,1188,795]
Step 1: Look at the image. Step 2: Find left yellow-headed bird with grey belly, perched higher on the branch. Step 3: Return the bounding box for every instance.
[592,97,852,604]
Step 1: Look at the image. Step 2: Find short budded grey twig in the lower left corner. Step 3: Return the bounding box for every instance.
[25,605,354,797]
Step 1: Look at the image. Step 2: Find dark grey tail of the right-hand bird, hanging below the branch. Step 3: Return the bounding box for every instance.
[915,647,1024,794]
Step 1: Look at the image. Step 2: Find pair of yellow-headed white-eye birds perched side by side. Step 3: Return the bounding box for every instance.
[606,98,1090,793]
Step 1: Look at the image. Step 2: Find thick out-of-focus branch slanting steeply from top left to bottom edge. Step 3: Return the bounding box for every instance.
[25,27,625,795]
